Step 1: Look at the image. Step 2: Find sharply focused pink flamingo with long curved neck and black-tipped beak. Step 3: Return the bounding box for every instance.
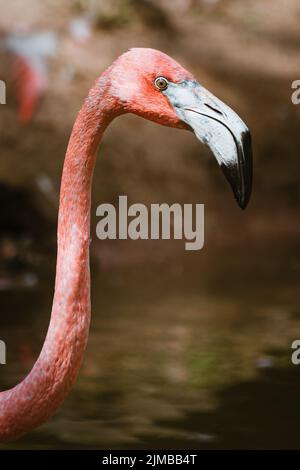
[0,48,252,442]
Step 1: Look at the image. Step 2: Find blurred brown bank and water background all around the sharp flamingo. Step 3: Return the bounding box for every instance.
[0,0,300,449]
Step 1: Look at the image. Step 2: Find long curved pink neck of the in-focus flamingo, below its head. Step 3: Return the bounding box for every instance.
[0,74,120,442]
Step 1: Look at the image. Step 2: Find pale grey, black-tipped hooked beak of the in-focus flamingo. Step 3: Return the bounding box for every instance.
[163,81,252,209]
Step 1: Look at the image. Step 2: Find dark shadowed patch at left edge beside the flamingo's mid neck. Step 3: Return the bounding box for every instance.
[0,183,55,291]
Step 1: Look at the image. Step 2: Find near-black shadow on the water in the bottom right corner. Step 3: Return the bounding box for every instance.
[141,366,300,450]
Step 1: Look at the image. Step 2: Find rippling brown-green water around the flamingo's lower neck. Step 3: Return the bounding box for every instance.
[1,244,300,449]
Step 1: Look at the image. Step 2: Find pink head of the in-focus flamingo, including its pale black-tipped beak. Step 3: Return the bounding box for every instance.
[110,48,252,209]
